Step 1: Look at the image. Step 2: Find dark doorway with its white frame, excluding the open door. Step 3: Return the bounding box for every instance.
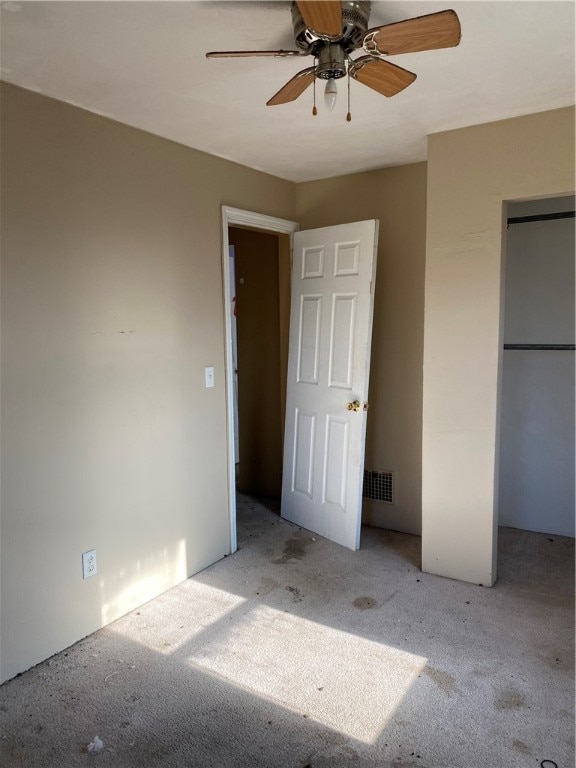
[222,206,298,552]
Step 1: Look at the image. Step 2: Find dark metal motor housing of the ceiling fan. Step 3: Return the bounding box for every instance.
[292,0,370,54]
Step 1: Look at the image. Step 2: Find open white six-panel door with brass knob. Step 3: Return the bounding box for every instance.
[281,221,378,549]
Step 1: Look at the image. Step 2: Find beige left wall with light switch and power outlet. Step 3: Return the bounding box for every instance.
[0,85,295,679]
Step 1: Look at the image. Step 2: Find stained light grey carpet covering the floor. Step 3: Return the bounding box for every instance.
[0,497,574,768]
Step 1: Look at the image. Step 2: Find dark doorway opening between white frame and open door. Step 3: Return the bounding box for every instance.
[228,227,290,499]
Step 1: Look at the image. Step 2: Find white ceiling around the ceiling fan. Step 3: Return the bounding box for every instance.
[0,0,575,181]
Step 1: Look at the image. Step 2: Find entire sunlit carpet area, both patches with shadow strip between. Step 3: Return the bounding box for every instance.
[115,579,427,744]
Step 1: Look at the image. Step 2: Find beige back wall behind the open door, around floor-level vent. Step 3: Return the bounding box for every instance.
[297,163,426,533]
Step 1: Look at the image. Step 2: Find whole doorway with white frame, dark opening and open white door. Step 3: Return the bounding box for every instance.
[223,210,378,551]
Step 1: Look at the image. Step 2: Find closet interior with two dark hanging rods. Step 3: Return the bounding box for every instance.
[498,196,575,537]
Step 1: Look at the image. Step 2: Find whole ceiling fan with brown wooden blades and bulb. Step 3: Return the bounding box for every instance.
[206,0,460,121]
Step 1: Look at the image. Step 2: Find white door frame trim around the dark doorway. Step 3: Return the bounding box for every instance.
[222,205,299,554]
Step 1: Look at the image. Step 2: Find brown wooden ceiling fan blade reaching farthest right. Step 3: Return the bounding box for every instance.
[362,10,461,56]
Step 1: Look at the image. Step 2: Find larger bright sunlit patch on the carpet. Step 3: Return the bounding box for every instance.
[187,605,426,744]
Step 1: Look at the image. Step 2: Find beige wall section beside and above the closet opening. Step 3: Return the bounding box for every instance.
[422,109,574,584]
